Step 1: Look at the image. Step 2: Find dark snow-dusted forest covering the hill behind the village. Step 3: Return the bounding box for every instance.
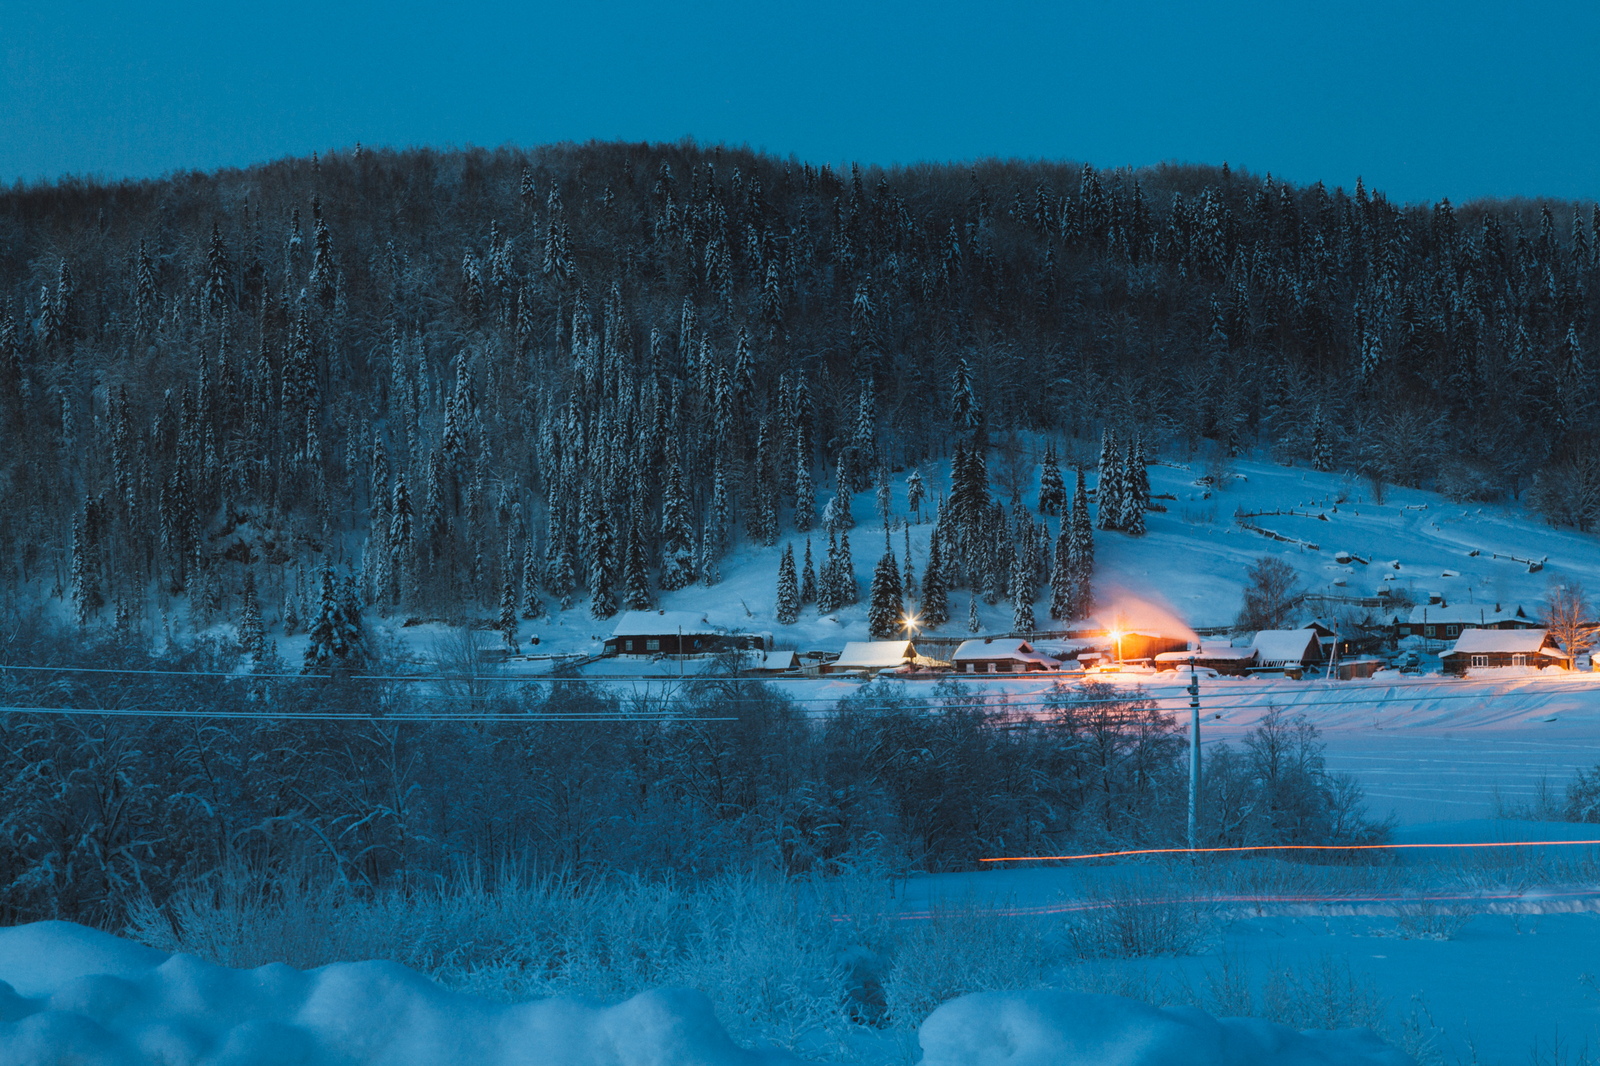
[0,144,1600,634]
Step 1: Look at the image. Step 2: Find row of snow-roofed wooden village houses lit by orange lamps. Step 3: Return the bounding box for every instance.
[602,605,1587,680]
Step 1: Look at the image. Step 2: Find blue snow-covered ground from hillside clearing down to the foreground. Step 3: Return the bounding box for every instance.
[12,451,1600,1066]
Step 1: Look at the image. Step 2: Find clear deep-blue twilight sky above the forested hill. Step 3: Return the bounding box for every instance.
[0,0,1600,202]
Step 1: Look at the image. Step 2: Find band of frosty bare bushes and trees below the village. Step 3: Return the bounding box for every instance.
[0,632,1382,927]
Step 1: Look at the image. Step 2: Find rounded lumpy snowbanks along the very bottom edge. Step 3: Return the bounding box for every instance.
[0,922,1408,1066]
